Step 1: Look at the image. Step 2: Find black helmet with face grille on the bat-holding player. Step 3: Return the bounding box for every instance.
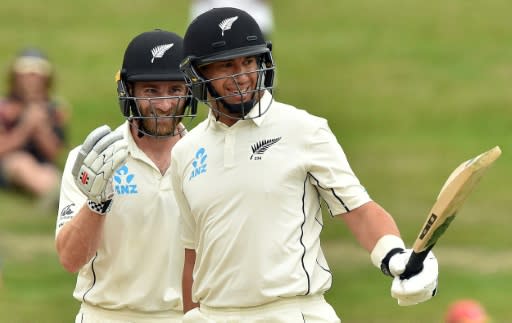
[180,7,275,119]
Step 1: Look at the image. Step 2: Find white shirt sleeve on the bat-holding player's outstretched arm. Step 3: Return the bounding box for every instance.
[307,119,371,216]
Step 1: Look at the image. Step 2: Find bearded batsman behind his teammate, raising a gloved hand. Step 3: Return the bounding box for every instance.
[56,30,195,323]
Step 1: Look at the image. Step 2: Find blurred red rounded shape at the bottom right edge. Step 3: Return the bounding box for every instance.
[445,299,490,323]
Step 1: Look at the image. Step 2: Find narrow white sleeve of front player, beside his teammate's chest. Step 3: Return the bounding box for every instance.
[171,154,196,250]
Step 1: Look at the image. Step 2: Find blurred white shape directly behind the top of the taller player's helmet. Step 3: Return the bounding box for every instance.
[190,0,274,40]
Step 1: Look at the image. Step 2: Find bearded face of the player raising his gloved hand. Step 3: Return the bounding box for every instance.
[133,81,187,136]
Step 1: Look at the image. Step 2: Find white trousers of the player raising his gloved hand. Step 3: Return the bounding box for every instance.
[75,303,183,323]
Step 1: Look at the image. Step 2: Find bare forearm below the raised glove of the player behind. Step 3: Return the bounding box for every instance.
[56,205,105,272]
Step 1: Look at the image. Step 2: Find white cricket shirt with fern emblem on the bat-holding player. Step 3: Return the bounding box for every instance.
[171,92,370,307]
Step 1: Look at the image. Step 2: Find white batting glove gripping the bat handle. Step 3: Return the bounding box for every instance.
[389,249,439,306]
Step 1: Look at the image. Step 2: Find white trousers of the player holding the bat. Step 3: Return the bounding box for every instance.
[183,295,341,323]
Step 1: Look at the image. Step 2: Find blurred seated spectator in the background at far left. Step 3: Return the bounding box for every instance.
[0,48,68,199]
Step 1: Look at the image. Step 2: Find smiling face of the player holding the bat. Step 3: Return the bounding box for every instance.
[201,56,258,104]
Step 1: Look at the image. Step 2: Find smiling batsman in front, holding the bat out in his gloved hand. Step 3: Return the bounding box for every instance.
[171,8,438,323]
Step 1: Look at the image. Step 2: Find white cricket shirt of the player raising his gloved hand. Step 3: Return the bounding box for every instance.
[56,122,184,312]
